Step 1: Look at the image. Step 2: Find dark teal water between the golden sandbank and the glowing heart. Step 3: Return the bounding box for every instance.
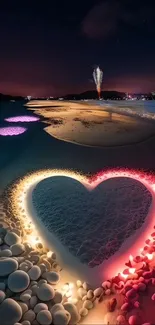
[0,102,155,191]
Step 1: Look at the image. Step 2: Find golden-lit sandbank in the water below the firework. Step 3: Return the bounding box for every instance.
[27,101,155,147]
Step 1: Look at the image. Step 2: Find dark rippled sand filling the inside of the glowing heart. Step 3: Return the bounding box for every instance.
[32,176,152,268]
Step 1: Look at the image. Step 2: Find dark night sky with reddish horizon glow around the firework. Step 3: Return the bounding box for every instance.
[0,0,155,96]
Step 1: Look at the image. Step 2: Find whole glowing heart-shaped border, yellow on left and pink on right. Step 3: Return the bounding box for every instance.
[8,169,155,286]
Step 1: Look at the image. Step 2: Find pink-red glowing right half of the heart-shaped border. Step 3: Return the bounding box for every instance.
[80,168,155,279]
